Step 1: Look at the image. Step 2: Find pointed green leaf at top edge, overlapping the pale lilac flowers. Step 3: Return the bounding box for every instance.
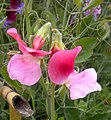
[83,0,103,11]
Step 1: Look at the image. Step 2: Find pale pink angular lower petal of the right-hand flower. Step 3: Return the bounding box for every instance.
[69,68,101,100]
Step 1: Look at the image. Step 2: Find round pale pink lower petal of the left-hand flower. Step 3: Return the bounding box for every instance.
[7,54,41,86]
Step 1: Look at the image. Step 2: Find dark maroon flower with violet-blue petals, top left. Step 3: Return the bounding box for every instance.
[3,0,24,28]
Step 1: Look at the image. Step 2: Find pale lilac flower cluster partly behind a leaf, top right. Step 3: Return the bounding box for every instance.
[84,0,101,21]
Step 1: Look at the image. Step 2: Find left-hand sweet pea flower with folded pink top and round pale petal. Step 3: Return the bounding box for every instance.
[7,28,50,86]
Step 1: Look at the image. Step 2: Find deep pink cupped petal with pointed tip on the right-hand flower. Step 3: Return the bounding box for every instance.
[48,46,81,84]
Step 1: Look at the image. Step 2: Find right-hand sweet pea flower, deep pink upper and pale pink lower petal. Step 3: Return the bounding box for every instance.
[48,46,101,100]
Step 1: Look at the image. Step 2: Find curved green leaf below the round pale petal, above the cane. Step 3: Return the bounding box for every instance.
[1,66,22,90]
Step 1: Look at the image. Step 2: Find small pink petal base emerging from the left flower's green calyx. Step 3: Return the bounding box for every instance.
[33,35,45,50]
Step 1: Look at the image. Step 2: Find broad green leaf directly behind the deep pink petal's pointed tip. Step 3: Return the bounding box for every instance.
[75,37,97,63]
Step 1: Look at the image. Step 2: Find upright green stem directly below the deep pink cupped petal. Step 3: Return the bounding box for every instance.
[51,83,55,120]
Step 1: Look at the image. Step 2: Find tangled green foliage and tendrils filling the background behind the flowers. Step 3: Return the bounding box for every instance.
[0,0,111,120]
